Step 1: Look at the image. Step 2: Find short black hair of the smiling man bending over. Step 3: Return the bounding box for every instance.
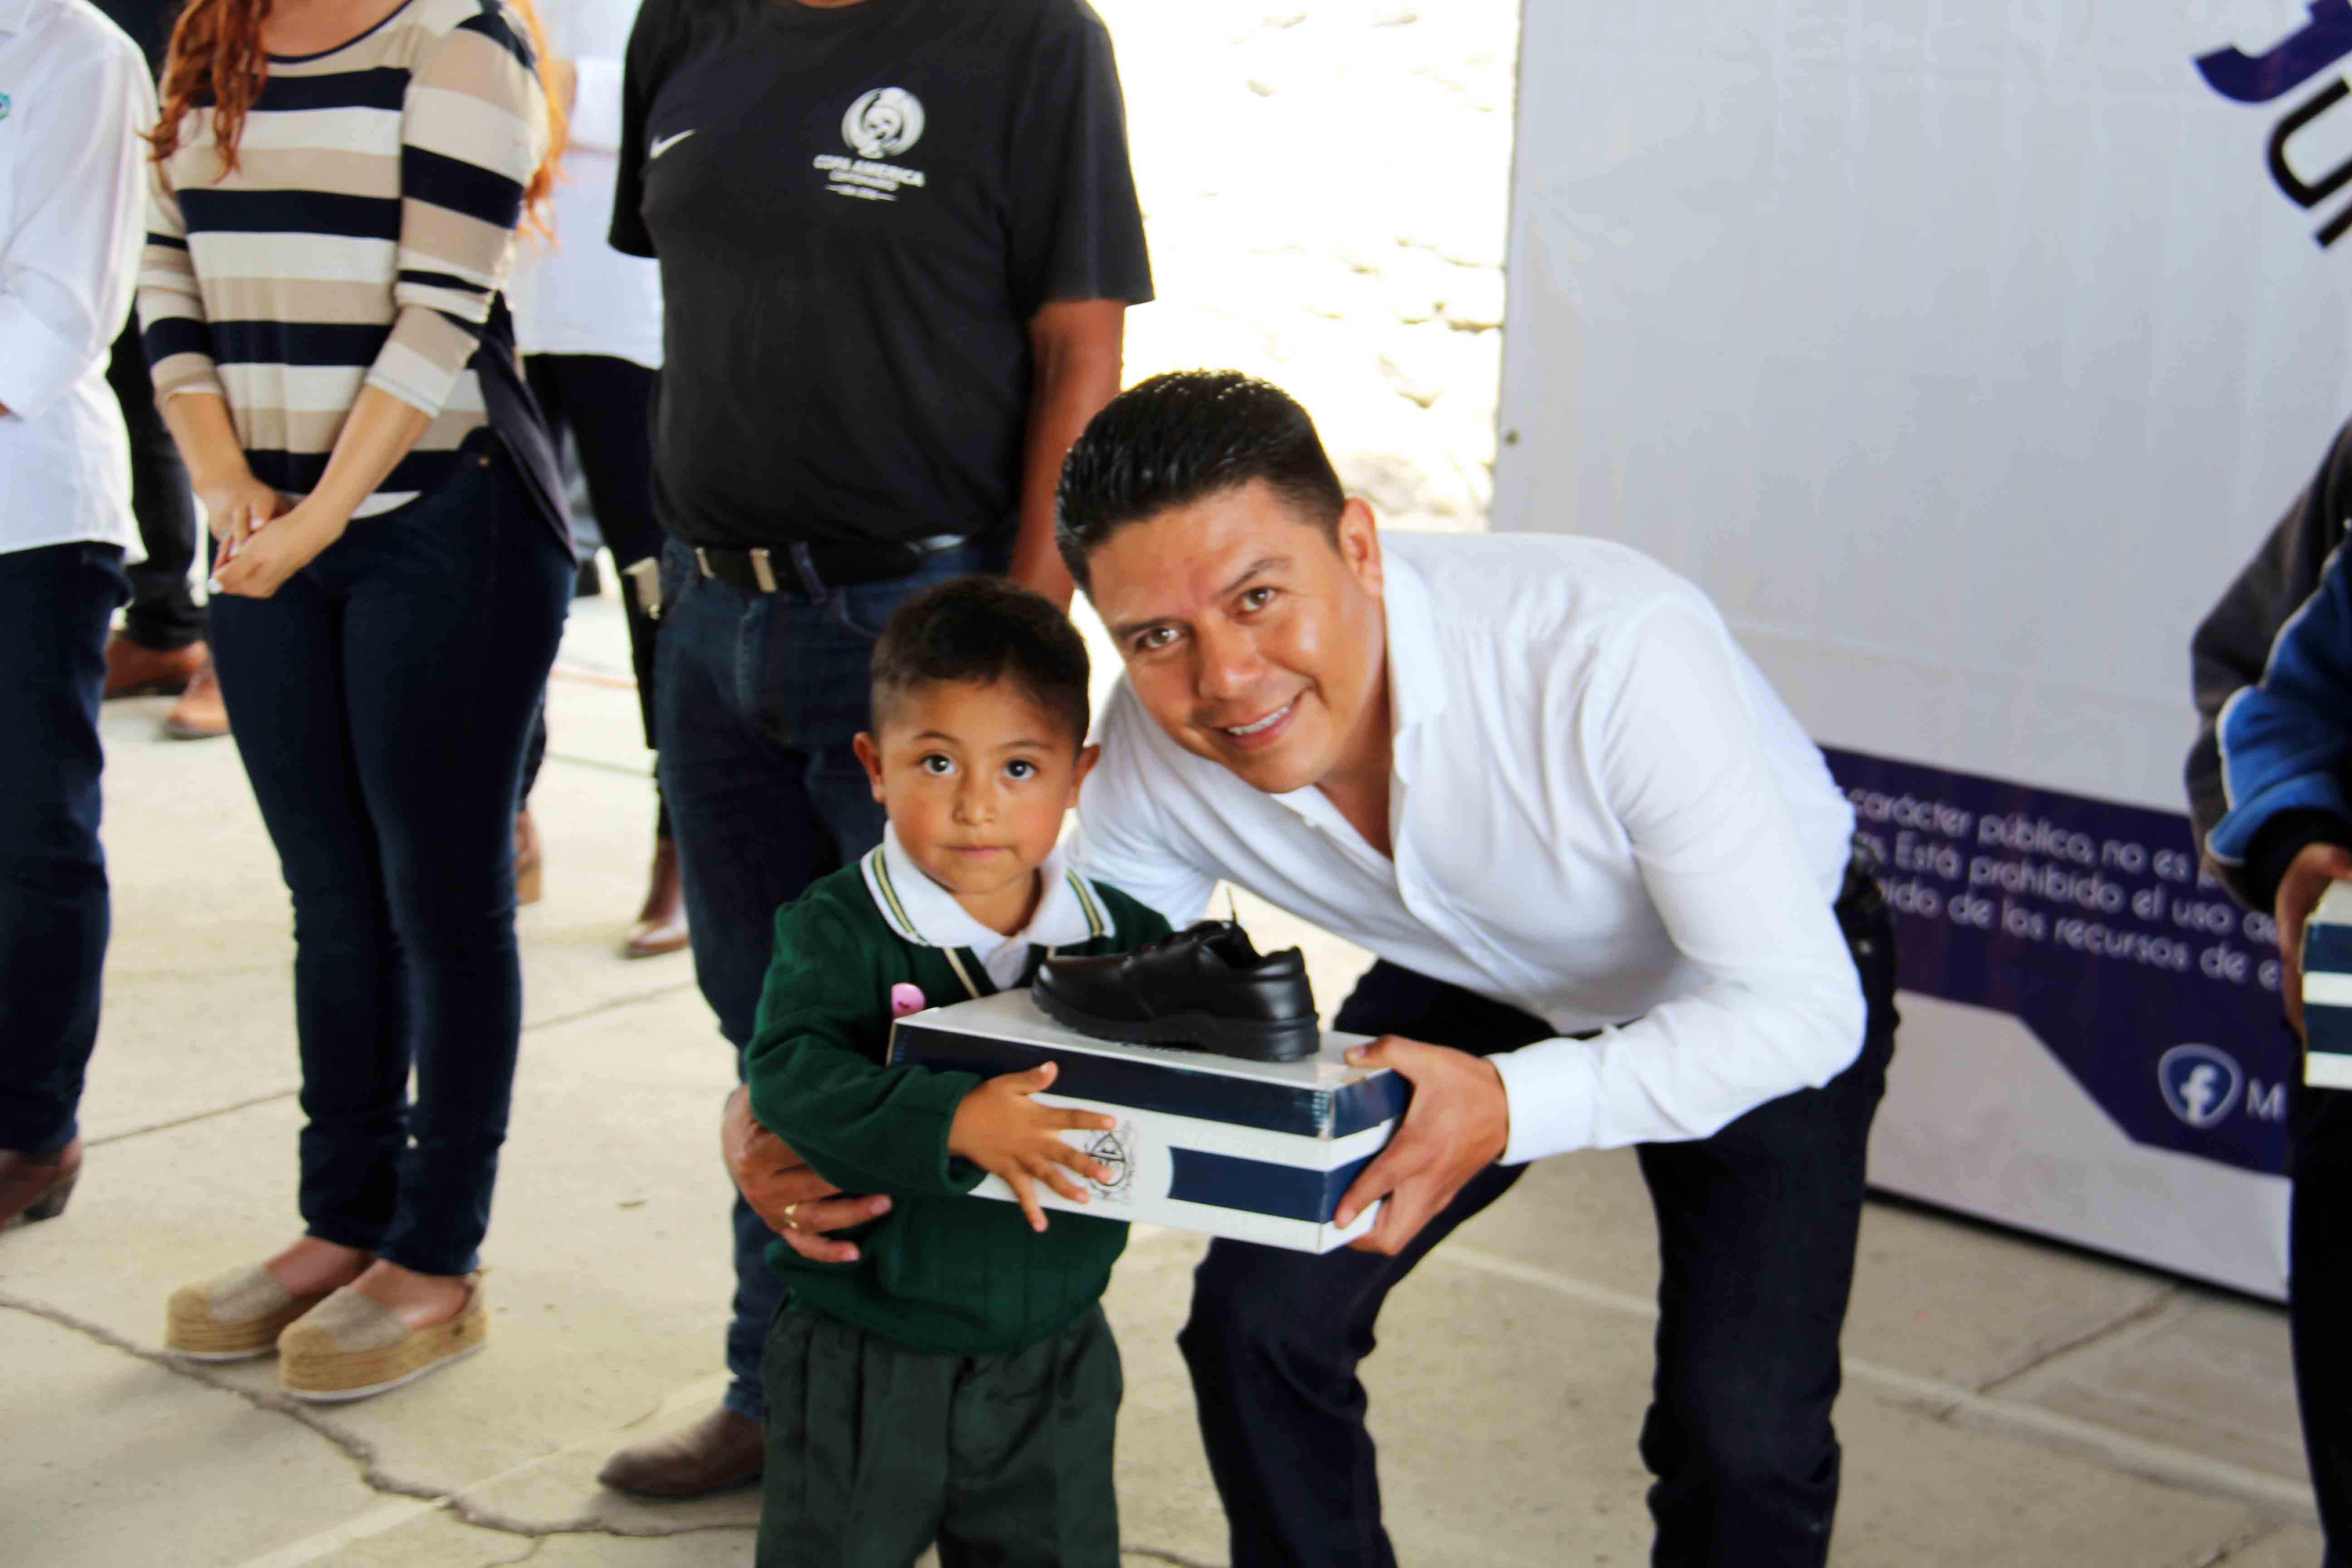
[1054,369,1348,588]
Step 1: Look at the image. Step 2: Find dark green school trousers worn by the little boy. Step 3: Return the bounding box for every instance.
[757,1307,1124,1568]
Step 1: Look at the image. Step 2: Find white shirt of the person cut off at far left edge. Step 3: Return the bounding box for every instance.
[0,0,155,557]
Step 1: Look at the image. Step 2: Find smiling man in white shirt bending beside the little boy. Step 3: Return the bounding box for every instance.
[727,372,1896,1568]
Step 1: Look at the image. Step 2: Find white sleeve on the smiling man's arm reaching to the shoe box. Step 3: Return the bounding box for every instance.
[1494,602,1865,1164]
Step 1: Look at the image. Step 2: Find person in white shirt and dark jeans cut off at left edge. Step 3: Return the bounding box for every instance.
[0,0,155,1230]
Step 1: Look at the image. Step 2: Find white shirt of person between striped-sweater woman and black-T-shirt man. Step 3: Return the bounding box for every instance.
[506,0,661,369]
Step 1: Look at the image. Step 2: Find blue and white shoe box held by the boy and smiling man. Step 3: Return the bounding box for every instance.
[889,990,1411,1253]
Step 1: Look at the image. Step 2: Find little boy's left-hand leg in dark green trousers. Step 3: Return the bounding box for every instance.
[757,1312,941,1568]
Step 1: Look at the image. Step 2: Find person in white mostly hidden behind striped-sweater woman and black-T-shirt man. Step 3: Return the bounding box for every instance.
[506,0,687,959]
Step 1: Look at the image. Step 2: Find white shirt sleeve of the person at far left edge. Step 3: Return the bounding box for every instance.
[0,28,155,418]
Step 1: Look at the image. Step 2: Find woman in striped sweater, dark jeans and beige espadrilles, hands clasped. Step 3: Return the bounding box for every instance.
[139,0,572,1399]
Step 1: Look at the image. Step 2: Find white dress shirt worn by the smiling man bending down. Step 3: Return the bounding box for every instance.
[1077,534,1863,1164]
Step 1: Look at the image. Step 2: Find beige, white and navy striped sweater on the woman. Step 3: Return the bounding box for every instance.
[139,0,548,517]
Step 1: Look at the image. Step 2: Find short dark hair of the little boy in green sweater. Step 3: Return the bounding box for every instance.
[870,576,1089,748]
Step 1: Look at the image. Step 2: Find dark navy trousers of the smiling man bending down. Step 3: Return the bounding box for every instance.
[1178,884,1896,1568]
